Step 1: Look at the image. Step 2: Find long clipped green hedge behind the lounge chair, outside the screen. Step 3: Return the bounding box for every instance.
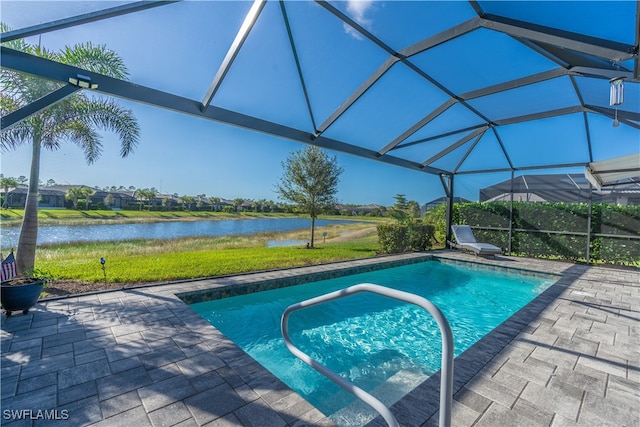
[453,202,640,265]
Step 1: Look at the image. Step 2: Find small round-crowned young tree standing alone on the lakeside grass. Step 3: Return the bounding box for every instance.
[276,145,343,248]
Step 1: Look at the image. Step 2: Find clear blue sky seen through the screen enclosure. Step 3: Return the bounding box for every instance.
[0,1,639,205]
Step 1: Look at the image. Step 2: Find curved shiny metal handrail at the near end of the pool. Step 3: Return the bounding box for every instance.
[280,283,453,427]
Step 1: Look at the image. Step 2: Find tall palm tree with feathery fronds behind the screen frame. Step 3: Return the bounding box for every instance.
[0,24,140,272]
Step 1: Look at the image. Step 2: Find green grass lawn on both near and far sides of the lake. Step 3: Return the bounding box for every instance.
[5,209,389,287]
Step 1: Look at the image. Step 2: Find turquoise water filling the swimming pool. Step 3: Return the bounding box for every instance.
[191,261,553,426]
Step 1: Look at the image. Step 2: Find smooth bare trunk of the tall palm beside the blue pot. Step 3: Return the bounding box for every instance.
[16,133,41,274]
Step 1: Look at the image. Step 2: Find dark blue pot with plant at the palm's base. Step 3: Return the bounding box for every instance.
[0,270,53,317]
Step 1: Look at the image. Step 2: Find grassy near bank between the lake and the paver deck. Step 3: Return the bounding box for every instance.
[22,217,378,296]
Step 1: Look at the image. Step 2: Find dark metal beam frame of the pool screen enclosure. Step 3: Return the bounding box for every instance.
[0,0,640,254]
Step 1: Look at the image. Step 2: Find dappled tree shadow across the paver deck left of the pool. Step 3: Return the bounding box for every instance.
[2,290,323,426]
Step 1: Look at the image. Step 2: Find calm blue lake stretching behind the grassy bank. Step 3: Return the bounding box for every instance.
[1,218,361,248]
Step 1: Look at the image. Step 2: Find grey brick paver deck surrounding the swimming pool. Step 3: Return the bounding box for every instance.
[0,251,640,427]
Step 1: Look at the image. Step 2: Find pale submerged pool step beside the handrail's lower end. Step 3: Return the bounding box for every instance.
[329,369,429,426]
